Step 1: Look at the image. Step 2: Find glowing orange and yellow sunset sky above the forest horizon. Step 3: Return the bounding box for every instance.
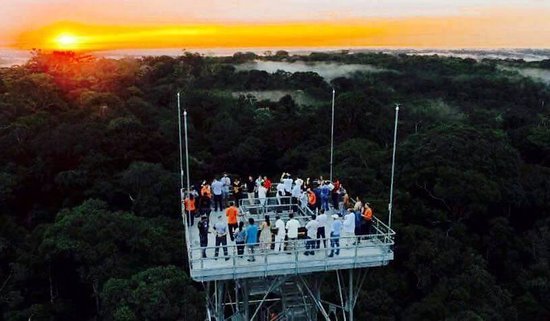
[0,0,550,51]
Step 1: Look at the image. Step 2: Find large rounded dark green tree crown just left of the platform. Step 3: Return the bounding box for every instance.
[39,200,183,312]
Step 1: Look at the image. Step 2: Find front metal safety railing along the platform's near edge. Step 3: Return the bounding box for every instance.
[191,234,394,281]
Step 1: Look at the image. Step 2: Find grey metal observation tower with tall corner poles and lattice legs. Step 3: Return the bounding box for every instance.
[178,93,399,321]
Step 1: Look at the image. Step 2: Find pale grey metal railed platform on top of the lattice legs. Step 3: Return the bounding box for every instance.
[186,198,395,282]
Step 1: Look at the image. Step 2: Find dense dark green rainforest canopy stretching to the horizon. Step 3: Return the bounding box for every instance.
[0,51,550,321]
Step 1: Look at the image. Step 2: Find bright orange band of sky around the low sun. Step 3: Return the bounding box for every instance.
[0,0,550,51]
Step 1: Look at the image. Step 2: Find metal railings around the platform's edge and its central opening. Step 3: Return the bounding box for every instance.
[188,197,395,278]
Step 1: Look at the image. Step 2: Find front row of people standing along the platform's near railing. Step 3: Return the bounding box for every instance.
[193,194,373,262]
